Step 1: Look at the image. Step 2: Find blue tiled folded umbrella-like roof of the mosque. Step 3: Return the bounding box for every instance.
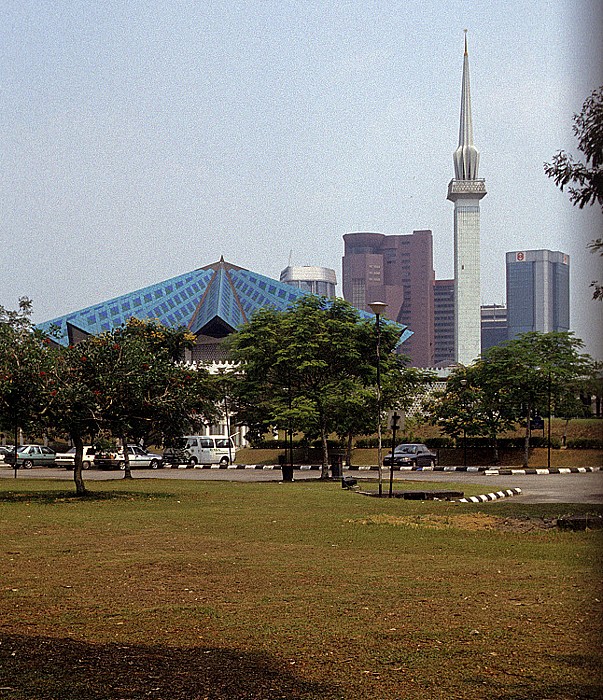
[38,259,410,345]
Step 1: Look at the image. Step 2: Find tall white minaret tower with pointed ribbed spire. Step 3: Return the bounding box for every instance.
[448,29,486,365]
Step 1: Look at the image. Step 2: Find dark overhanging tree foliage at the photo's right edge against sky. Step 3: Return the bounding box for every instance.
[544,86,603,299]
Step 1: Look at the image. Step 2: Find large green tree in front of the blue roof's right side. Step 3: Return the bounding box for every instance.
[228,296,410,478]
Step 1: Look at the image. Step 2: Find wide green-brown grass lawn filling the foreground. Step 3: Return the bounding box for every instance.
[0,478,603,700]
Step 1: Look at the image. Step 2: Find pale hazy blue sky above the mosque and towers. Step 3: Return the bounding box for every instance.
[0,0,603,359]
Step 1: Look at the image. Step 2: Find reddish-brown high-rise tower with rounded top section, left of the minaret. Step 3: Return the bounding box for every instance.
[343,231,435,367]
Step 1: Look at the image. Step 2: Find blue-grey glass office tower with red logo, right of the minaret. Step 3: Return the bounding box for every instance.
[506,250,569,339]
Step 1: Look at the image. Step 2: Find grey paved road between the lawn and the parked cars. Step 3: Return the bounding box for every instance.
[0,465,603,504]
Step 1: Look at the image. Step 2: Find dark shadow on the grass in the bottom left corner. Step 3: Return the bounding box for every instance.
[0,635,341,700]
